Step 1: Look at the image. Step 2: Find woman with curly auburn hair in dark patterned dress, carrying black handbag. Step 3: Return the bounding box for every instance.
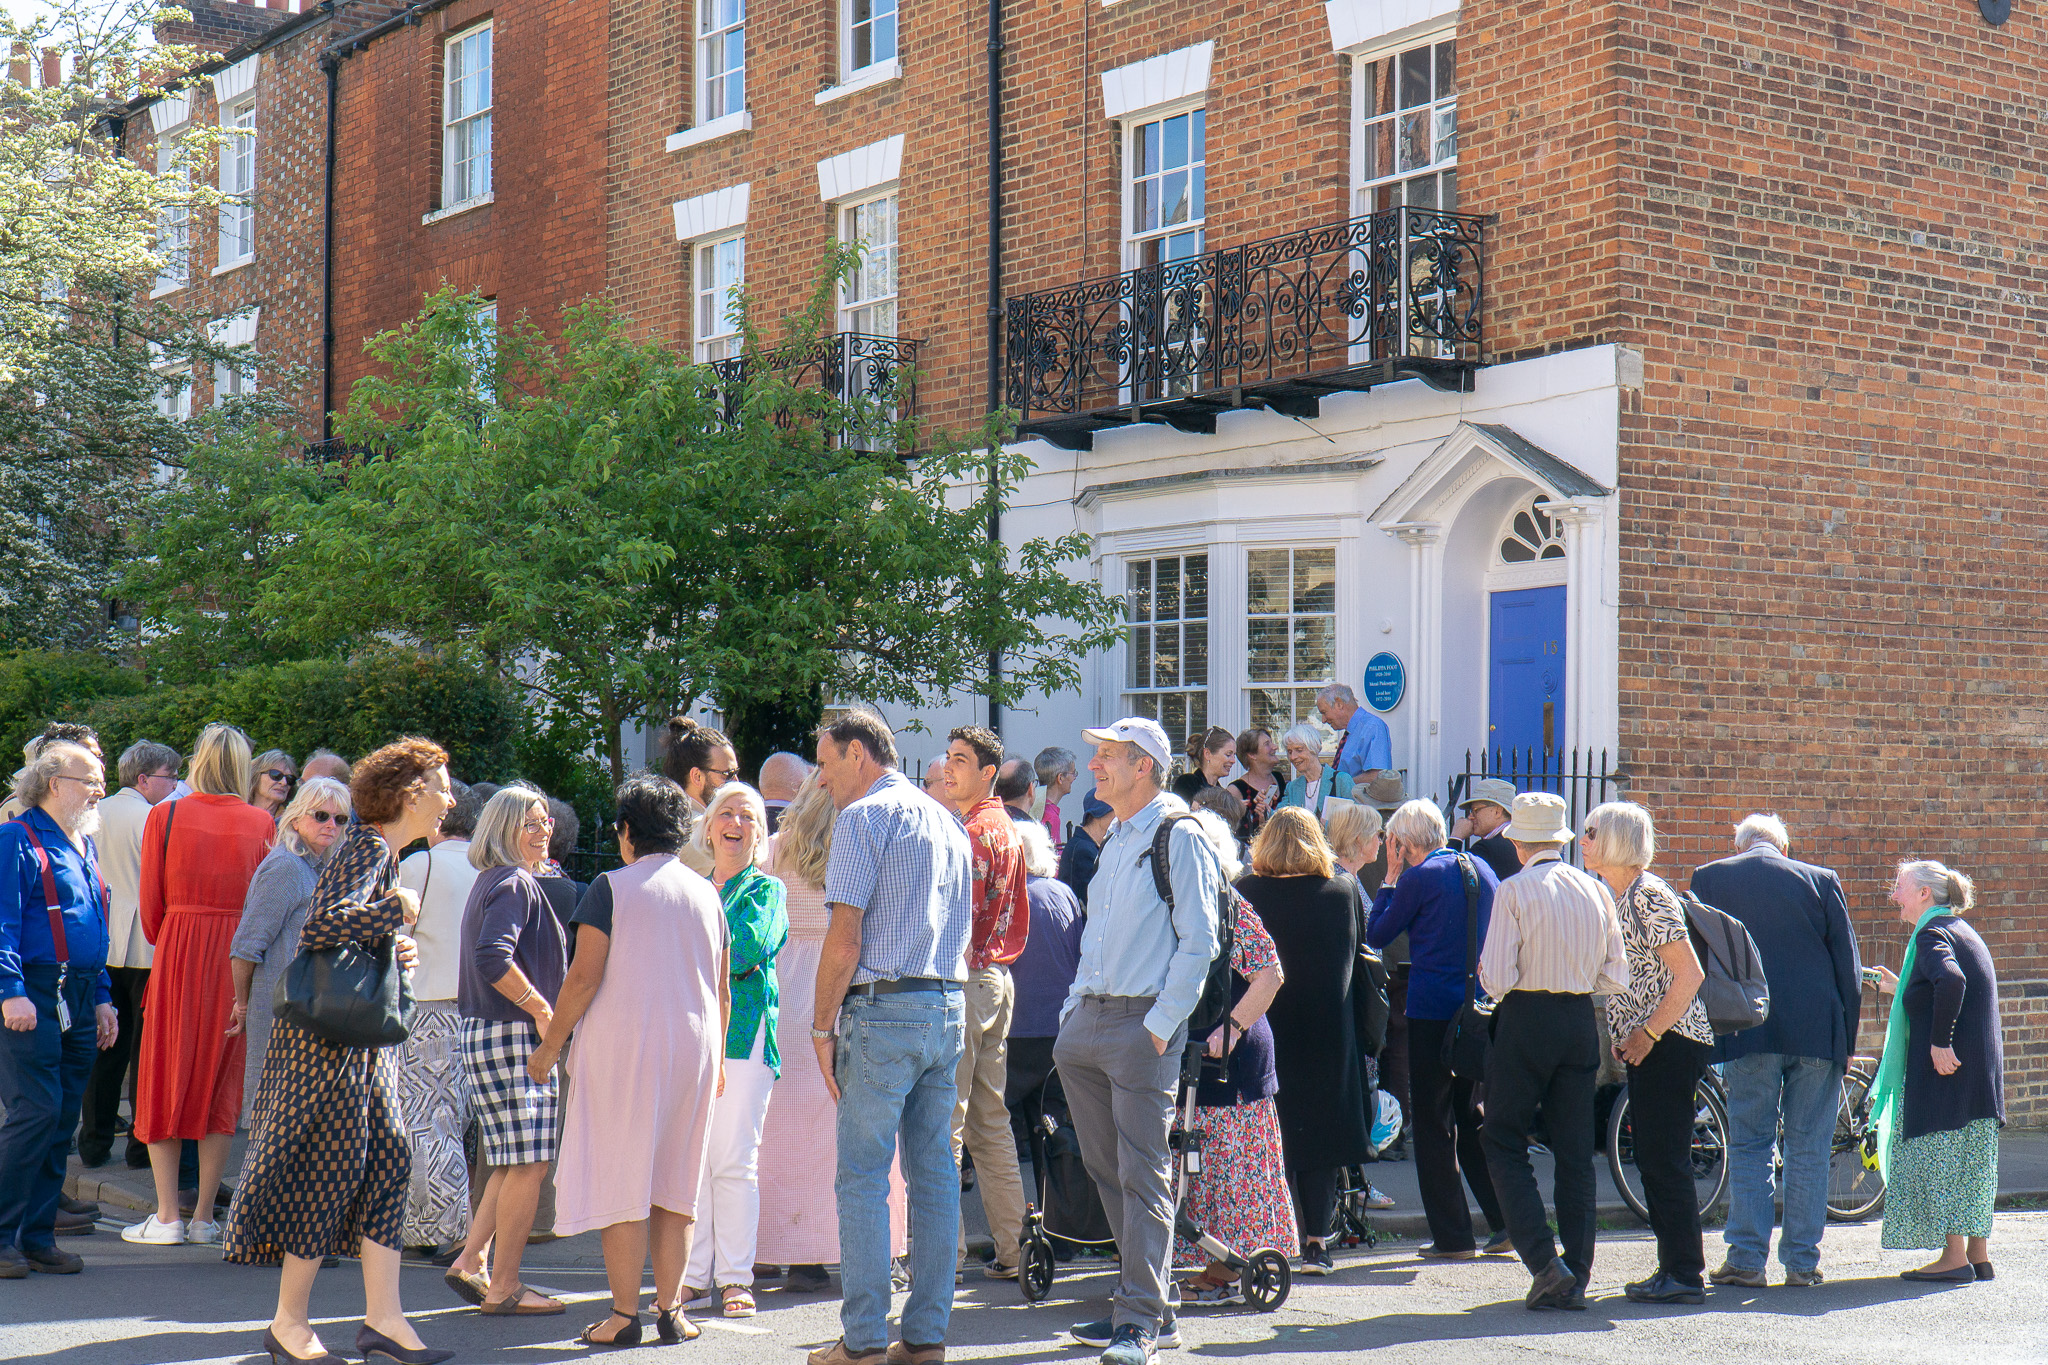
[221,739,455,1365]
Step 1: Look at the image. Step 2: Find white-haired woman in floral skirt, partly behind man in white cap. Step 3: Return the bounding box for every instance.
[1174,810,1298,1304]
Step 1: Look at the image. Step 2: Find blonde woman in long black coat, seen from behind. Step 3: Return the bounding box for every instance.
[1237,806,1370,1275]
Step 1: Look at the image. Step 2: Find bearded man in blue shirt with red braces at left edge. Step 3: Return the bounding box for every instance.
[0,743,121,1279]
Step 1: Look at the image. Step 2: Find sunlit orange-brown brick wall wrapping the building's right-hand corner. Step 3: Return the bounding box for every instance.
[1460,0,2048,1031]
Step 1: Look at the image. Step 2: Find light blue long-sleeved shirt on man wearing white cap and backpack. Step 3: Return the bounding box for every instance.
[1056,792,1223,1038]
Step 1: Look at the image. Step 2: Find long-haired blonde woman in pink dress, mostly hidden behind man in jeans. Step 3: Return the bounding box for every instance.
[754,774,907,1293]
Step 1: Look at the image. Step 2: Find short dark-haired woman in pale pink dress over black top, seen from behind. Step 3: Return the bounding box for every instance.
[526,774,731,1347]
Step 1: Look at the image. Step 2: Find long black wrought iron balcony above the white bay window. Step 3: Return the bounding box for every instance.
[1006,207,1487,450]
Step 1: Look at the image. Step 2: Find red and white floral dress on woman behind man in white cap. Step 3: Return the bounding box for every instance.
[1174,902,1300,1269]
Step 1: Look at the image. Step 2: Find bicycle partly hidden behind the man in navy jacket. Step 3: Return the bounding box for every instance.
[1608,1058,1884,1222]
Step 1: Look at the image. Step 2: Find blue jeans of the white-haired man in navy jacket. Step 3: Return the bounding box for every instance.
[1722,1052,1843,1271]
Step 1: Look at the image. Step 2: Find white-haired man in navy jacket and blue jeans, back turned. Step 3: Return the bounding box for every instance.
[1692,810,1864,1289]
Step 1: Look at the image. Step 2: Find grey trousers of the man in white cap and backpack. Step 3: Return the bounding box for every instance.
[1053,995,1188,1332]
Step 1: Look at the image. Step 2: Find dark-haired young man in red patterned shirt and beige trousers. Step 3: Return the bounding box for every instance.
[940,724,1030,1279]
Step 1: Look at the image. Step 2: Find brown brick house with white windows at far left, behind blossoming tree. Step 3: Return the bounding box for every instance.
[121,0,395,440]
